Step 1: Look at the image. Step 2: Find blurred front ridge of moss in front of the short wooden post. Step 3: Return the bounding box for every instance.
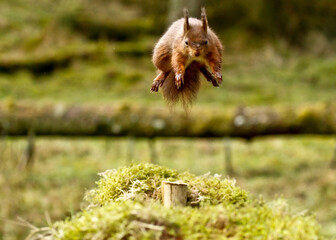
[53,201,319,240]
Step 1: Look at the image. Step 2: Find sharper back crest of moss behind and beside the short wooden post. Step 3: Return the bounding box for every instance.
[86,164,247,205]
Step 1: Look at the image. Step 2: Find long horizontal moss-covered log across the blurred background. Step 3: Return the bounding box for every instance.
[0,102,336,139]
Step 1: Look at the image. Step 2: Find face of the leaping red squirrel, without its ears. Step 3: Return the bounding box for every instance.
[183,32,209,57]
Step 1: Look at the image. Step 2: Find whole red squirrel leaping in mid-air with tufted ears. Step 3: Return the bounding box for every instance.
[151,8,223,108]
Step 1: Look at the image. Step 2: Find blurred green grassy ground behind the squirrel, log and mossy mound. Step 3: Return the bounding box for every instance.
[0,0,336,240]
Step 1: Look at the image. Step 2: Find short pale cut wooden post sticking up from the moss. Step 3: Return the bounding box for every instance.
[161,181,188,207]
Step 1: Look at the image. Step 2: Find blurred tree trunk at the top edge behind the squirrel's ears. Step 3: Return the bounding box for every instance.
[167,0,205,26]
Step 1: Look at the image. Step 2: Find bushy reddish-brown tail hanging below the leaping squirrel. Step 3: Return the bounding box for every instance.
[161,63,200,110]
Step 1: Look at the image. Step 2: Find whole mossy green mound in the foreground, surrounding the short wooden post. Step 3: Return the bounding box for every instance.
[31,164,322,240]
